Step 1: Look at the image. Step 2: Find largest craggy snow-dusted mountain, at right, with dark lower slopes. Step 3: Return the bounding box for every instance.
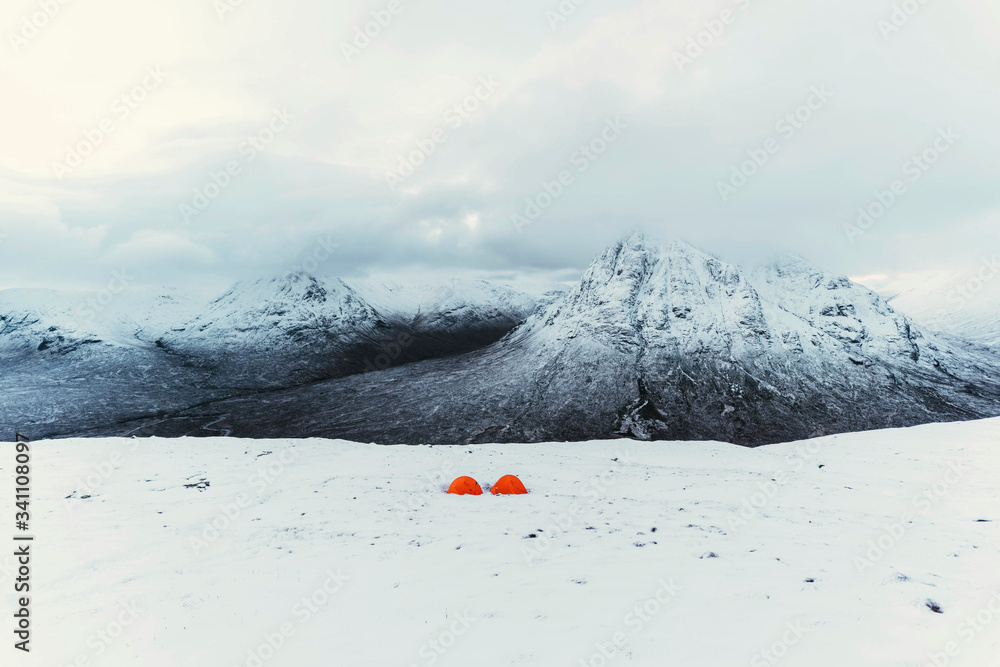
[145,235,1000,444]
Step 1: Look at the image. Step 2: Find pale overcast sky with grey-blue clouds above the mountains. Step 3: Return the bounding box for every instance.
[0,0,1000,288]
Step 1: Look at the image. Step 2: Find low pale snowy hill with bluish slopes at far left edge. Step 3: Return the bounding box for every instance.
[0,289,223,435]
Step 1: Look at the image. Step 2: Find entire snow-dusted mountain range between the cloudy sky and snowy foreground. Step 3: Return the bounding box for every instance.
[0,234,1000,445]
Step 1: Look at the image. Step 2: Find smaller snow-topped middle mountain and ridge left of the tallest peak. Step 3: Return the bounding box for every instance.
[157,273,535,388]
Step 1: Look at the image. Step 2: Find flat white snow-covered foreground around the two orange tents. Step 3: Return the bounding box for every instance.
[7,419,1000,667]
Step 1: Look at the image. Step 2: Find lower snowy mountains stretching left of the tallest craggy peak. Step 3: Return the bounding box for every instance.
[0,273,534,435]
